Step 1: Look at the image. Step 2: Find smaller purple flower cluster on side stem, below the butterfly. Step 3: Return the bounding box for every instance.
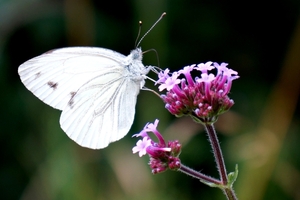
[132,119,181,174]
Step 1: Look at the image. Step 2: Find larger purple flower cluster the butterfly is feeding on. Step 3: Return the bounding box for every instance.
[156,62,239,123]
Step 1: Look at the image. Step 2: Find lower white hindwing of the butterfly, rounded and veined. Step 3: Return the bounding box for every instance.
[60,72,139,149]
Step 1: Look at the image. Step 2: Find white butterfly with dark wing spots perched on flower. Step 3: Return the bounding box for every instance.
[18,47,153,149]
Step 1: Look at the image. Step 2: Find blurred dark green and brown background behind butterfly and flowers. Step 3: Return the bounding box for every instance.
[0,0,300,200]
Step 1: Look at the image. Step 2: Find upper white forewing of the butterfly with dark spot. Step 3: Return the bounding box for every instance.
[18,47,126,110]
